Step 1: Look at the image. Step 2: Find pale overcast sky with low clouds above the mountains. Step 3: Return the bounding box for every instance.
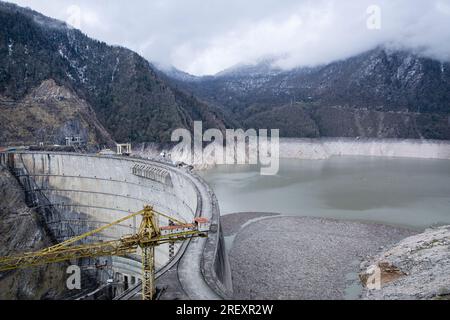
[10,0,450,75]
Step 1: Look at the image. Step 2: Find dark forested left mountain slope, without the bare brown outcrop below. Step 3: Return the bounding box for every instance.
[0,2,225,142]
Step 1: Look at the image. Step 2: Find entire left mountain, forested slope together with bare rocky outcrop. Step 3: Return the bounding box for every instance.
[0,2,230,144]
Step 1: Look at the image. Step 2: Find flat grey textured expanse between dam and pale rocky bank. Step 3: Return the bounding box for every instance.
[222,213,417,300]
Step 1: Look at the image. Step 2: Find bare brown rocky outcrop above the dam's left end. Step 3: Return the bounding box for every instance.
[0,80,113,145]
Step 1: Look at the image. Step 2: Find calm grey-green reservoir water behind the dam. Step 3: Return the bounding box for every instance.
[201,157,450,229]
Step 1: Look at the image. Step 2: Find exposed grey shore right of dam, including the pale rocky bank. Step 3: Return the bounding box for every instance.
[222,212,450,300]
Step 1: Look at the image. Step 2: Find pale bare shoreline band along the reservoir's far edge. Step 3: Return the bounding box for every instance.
[133,138,450,170]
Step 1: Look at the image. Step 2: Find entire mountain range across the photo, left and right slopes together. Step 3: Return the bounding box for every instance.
[0,2,450,142]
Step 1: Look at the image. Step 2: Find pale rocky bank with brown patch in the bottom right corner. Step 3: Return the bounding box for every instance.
[361,226,450,300]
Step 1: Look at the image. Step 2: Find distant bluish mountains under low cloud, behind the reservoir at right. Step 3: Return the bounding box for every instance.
[170,48,450,139]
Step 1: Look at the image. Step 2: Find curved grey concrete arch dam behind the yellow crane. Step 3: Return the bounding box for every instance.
[0,152,232,299]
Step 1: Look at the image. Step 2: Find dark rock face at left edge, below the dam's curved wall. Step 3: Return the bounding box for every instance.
[0,167,67,300]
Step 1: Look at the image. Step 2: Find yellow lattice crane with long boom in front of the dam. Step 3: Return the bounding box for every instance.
[0,206,209,300]
